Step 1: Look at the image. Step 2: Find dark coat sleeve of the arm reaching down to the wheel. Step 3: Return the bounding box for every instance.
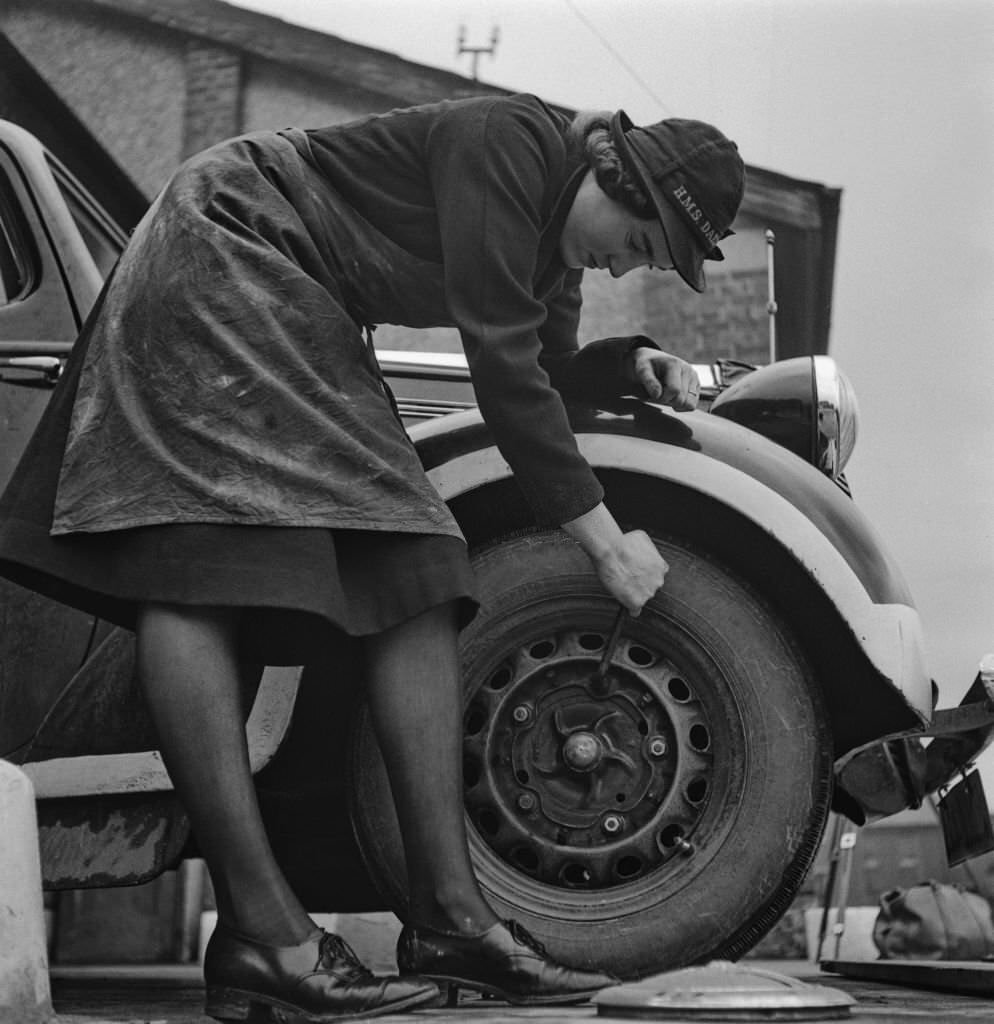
[429,97,604,524]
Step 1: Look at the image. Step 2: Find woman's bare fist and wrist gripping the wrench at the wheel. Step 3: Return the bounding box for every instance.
[563,504,669,615]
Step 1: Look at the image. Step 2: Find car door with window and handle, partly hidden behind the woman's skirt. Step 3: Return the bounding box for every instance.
[0,124,123,761]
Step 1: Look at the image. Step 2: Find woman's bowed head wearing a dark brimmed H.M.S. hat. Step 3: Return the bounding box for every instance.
[560,111,744,292]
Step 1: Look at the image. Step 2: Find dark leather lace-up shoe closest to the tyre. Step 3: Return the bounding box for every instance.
[397,921,618,1006]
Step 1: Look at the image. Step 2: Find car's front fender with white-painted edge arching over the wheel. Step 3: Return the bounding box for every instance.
[410,400,932,754]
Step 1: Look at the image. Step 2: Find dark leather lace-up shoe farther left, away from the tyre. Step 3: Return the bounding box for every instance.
[204,925,439,1024]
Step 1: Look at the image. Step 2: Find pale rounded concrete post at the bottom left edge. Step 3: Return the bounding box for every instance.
[0,760,56,1024]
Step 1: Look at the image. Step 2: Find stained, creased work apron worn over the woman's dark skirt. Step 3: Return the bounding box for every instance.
[51,130,461,537]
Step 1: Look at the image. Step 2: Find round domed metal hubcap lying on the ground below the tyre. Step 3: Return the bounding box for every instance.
[594,961,855,1021]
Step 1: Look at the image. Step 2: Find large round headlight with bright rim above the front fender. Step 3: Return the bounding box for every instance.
[710,355,859,479]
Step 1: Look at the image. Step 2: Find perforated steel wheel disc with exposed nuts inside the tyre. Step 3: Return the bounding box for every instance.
[464,618,714,889]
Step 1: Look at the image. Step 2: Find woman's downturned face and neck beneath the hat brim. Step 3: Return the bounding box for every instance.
[559,173,673,278]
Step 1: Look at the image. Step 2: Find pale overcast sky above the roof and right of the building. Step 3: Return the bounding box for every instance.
[235,0,994,705]
